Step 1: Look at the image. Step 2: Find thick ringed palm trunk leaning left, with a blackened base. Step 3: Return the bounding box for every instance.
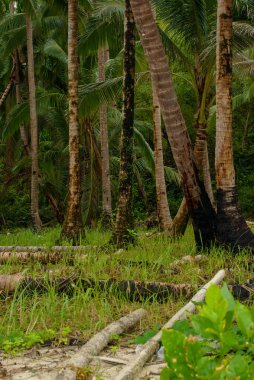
[130,0,215,247]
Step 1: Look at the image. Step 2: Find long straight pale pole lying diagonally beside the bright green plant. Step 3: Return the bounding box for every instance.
[115,270,225,380]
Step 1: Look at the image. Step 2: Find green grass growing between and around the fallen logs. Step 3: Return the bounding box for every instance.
[0,228,253,352]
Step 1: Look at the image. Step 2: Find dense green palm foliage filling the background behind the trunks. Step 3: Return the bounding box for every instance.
[0,0,254,246]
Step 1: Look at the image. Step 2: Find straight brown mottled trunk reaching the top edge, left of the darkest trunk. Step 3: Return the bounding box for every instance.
[61,0,82,245]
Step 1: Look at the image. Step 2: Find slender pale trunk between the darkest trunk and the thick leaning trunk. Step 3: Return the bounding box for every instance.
[153,86,172,233]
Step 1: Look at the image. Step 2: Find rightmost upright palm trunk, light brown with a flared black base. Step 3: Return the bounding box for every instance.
[215,0,254,250]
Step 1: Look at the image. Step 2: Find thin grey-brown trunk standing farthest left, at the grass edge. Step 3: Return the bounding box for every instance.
[26,14,42,230]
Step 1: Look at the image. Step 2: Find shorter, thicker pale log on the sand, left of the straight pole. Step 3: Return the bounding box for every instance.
[55,309,146,380]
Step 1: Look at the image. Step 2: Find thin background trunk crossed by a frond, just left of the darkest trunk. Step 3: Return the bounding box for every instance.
[98,49,112,228]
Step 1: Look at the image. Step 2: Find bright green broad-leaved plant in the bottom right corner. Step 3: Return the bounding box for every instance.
[161,284,254,380]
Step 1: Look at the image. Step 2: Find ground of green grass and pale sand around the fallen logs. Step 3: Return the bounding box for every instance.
[0,228,254,380]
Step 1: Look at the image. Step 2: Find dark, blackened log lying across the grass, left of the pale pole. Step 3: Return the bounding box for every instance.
[0,273,197,301]
